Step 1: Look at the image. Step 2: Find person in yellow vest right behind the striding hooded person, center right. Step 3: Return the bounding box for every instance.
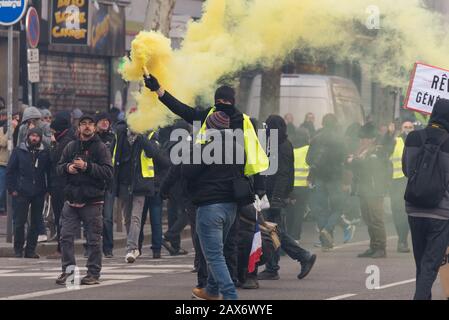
[285,129,310,240]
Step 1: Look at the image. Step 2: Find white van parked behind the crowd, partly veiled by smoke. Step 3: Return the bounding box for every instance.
[247,74,364,129]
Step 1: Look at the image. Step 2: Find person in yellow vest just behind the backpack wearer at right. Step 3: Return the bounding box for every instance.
[390,121,415,253]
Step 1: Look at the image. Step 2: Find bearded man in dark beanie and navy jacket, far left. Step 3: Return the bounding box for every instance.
[6,128,51,258]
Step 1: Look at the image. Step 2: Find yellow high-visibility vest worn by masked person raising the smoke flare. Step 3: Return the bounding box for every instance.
[195,107,270,176]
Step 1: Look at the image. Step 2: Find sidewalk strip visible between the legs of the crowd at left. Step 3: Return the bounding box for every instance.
[0,216,190,258]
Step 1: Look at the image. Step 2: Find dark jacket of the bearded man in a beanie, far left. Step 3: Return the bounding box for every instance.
[6,142,51,197]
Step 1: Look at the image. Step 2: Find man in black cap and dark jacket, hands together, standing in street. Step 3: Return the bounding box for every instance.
[56,114,113,285]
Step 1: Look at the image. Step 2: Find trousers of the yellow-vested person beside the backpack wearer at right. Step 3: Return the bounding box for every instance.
[390,178,409,244]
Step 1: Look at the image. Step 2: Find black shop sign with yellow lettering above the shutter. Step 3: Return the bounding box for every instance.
[50,0,89,45]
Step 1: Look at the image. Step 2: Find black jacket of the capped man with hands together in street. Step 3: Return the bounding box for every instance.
[56,135,112,204]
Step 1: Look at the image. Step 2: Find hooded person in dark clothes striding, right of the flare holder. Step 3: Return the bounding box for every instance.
[258,115,316,280]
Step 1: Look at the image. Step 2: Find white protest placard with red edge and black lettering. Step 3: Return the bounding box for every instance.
[404,62,449,114]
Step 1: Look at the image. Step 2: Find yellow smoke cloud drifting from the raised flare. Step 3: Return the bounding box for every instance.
[123,0,449,132]
